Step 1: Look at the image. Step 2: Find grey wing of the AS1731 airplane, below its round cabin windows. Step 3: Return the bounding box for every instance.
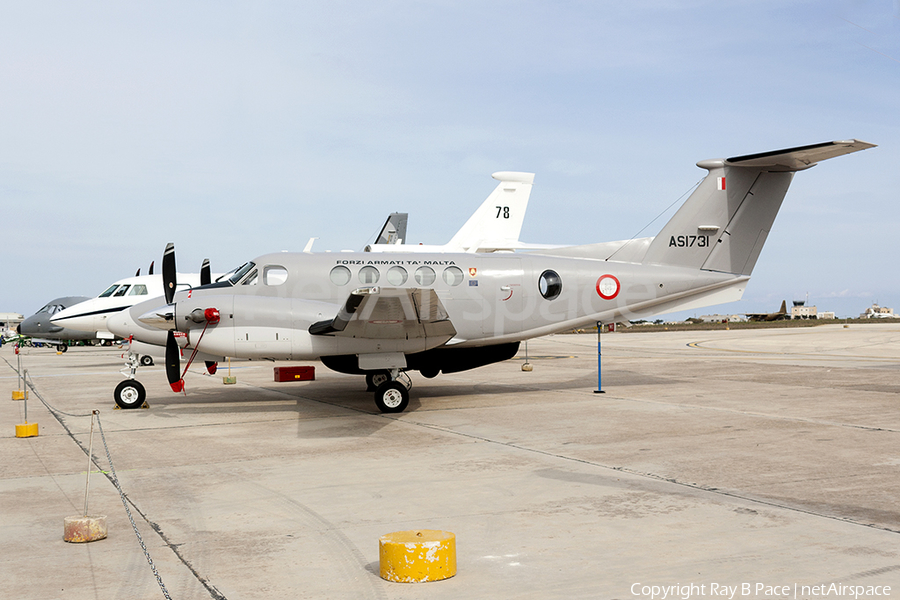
[309,287,456,341]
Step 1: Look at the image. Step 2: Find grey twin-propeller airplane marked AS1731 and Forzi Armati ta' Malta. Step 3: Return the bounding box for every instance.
[108,140,873,412]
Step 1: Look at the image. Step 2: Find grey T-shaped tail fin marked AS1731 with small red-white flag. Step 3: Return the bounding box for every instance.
[643,140,874,275]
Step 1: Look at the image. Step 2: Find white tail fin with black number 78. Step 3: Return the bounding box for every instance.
[447,171,534,252]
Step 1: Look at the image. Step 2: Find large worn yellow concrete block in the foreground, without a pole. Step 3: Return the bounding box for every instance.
[378,529,456,583]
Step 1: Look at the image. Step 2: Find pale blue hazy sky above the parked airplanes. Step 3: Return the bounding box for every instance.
[0,0,900,316]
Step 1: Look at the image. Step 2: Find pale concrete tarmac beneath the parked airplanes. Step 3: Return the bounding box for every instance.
[0,323,900,600]
